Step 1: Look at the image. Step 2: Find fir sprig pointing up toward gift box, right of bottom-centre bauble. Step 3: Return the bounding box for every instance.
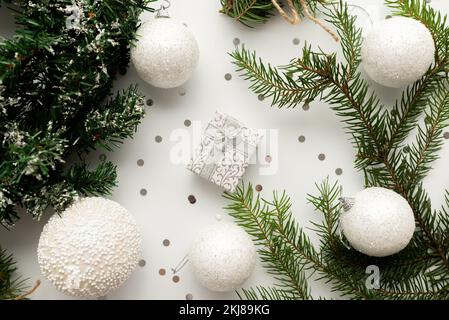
[225,185,317,299]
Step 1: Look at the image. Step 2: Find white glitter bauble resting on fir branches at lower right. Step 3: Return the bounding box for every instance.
[341,188,415,257]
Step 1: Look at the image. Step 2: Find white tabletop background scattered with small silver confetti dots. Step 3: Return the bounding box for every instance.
[0,0,449,299]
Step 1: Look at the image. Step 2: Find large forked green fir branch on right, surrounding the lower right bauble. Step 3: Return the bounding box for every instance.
[228,0,449,299]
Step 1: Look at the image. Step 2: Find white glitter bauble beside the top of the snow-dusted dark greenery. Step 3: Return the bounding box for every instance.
[131,17,199,88]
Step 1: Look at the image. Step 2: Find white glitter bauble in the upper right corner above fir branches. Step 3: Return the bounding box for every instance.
[362,17,435,88]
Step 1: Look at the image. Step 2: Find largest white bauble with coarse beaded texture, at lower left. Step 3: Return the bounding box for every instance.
[37,197,141,298]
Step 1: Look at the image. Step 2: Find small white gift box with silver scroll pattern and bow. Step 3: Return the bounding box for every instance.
[187,112,263,192]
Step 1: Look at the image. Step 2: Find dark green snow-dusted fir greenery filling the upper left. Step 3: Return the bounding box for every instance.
[0,0,152,227]
